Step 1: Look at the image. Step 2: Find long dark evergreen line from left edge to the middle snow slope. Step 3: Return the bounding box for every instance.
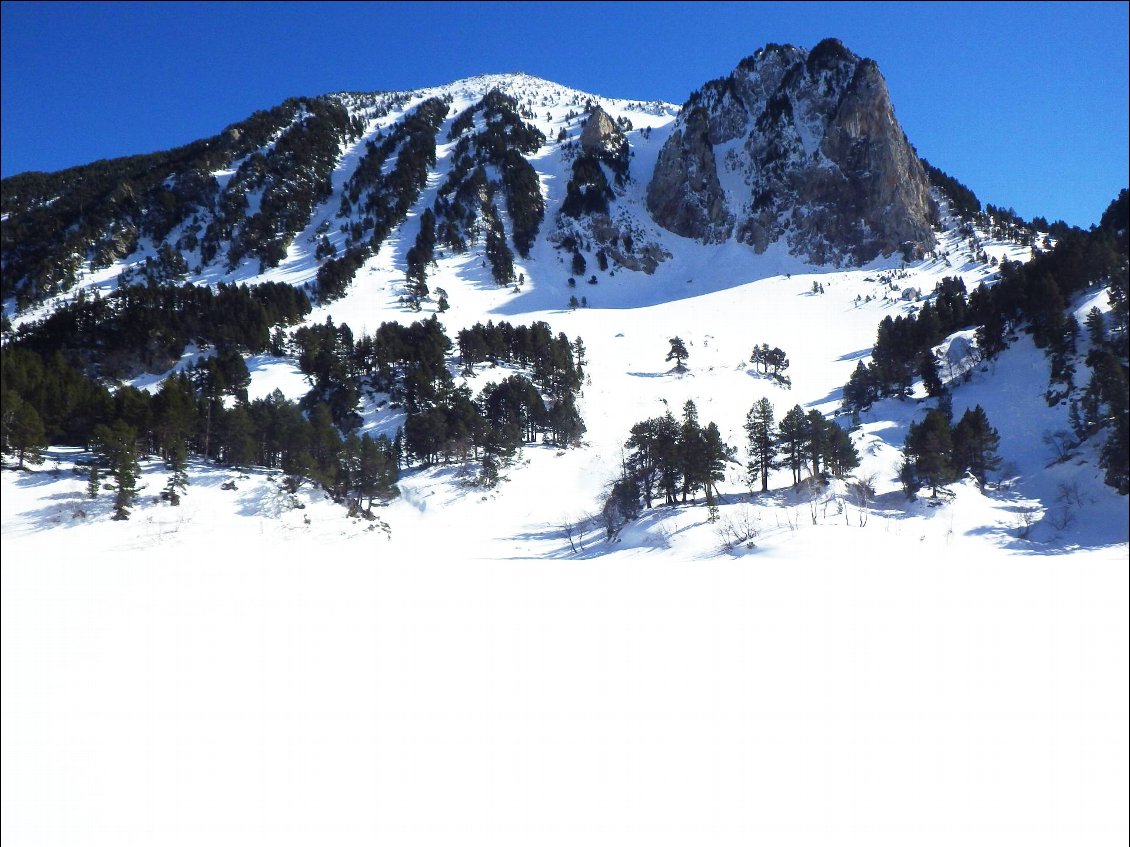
[0,307,585,517]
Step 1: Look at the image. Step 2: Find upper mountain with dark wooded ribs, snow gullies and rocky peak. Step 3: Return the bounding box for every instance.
[2,40,938,311]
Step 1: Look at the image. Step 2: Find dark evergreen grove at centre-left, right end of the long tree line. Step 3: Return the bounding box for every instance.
[287,316,585,482]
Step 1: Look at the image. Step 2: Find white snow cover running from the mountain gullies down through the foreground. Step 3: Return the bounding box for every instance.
[0,72,1130,846]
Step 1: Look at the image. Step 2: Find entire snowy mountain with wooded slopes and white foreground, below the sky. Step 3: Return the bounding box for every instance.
[0,42,1128,845]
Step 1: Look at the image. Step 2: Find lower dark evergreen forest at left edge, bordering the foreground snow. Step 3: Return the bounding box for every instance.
[0,348,401,518]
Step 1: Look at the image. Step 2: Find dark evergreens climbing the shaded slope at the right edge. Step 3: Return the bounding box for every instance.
[843,190,1130,494]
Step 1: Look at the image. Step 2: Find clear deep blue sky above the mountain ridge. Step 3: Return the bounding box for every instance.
[0,2,1130,227]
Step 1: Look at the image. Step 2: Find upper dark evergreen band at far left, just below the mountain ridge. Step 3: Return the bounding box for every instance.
[5,282,310,378]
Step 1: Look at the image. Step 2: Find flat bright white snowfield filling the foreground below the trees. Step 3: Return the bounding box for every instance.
[2,465,1130,847]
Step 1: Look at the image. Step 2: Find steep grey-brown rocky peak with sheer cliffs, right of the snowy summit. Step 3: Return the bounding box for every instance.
[647,38,937,264]
